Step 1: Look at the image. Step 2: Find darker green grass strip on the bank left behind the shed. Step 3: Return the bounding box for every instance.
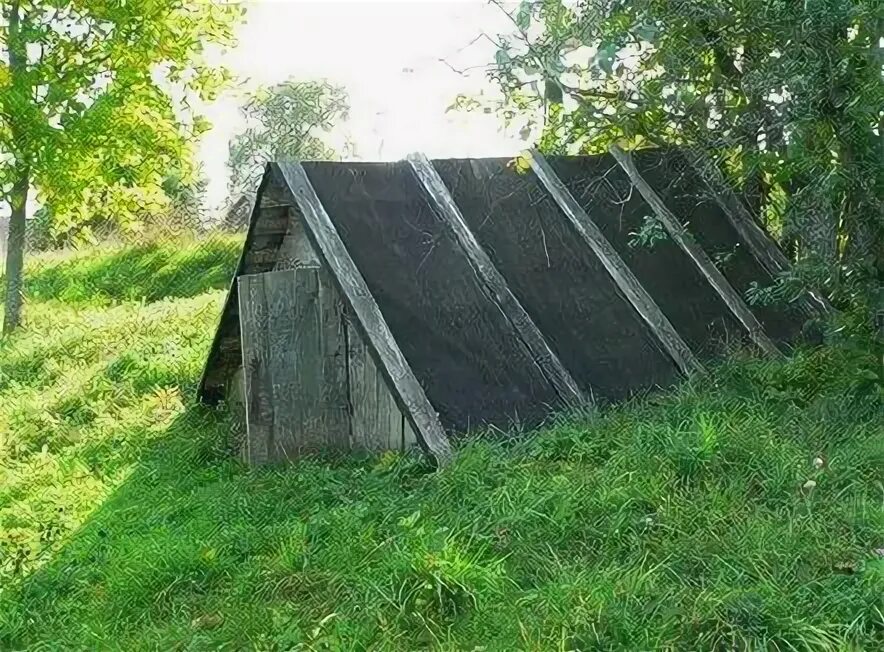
[11,236,241,305]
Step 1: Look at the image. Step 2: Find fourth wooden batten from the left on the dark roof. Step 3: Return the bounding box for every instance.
[610,144,782,356]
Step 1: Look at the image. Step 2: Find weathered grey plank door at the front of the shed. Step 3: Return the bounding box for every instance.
[238,267,350,464]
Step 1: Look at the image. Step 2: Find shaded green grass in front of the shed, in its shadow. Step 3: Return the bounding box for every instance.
[0,344,884,650]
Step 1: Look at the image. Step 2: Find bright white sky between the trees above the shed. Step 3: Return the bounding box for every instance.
[200,0,521,205]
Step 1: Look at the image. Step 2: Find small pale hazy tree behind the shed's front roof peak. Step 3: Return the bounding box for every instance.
[228,80,349,222]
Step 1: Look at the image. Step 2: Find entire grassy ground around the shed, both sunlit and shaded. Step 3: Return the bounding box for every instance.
[0,240,884,650]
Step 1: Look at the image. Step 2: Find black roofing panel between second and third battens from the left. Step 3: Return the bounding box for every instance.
[436,159,678,400]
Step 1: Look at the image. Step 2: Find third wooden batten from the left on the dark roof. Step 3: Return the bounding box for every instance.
[529,150,705,375]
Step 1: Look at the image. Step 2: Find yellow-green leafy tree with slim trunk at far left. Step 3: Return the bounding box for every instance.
[0,0,242,332]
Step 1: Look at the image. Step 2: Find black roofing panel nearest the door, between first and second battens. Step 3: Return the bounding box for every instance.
[304,162,557,430]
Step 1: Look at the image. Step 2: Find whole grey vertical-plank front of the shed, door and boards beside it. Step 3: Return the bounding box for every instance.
[231,262,416,465]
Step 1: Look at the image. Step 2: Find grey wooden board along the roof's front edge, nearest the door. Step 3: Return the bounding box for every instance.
[277,162,452,466]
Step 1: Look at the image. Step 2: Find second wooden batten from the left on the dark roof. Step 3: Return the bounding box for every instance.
[408,153,589,407]
